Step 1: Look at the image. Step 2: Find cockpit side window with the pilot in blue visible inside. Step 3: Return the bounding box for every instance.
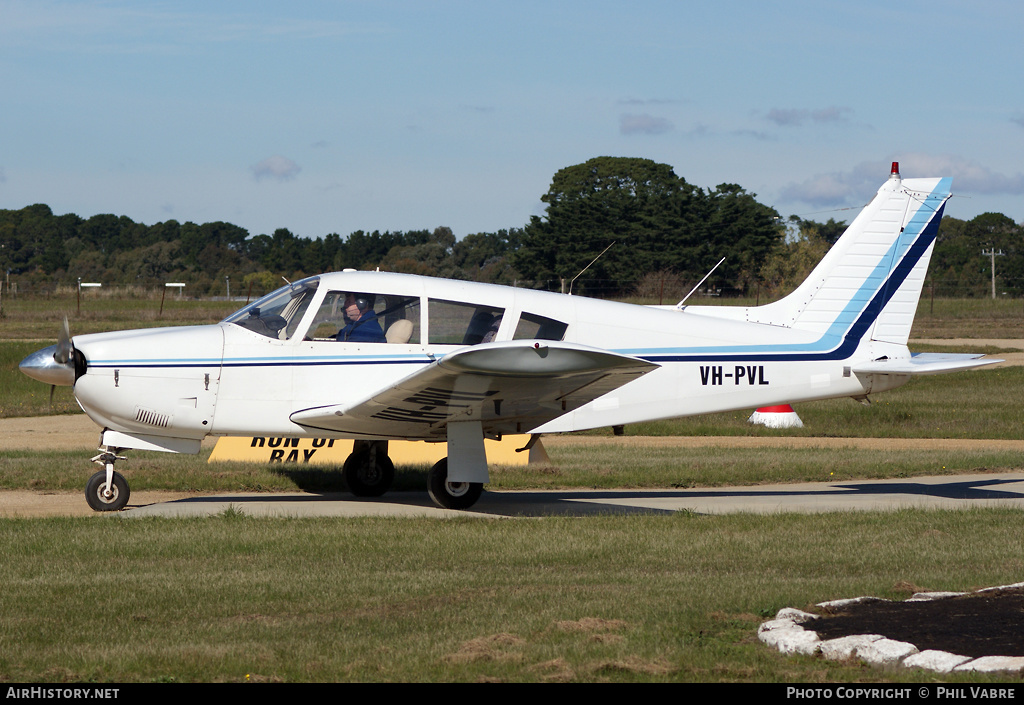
[306,291,420,344]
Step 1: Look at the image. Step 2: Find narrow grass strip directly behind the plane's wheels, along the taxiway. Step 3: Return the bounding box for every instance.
[0,444,1024,501]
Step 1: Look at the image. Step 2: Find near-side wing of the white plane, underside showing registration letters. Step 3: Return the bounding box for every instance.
[291,340,658,441]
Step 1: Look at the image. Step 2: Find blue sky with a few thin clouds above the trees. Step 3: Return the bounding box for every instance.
[0,0,1024,238]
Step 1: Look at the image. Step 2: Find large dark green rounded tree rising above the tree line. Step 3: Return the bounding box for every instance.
[512,157,783,294]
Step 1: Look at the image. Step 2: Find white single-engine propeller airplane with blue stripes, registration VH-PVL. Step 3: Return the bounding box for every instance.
[20,163,999,511]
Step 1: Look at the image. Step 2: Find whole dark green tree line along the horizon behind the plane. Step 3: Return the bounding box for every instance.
[0,157,1024,299]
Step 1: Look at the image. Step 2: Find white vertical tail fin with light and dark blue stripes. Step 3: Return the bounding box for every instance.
[746,162,952,345]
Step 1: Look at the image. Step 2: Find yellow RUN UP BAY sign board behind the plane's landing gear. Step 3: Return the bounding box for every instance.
[202,434,550,467]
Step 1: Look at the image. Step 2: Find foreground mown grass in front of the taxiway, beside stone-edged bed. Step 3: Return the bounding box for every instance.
[0,510,1024,682]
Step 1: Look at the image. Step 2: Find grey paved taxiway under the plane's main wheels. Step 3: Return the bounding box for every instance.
[120,472,1024,517]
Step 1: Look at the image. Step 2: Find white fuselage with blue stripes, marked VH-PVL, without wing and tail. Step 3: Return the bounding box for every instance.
[74,273,908,440]
